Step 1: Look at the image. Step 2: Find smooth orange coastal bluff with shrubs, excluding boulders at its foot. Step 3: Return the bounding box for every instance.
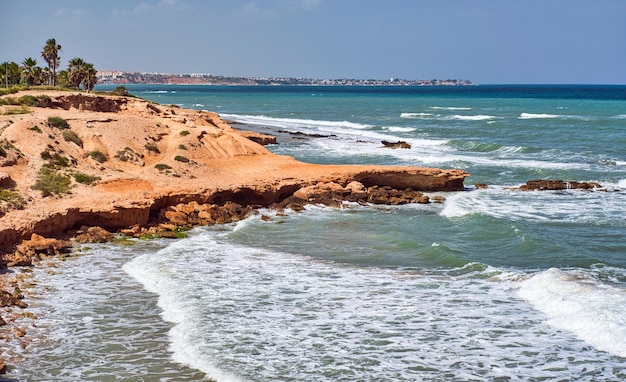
[0,90,468,254]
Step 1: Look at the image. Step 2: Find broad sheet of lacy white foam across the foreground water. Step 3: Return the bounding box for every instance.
[118,225,624,381]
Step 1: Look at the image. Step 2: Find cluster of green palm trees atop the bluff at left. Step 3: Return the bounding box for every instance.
[0,38,98,91]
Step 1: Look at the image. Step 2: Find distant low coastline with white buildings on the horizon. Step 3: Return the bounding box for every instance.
[97,70,473,86]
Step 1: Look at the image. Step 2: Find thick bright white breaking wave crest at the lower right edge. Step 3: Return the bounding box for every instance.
[519,268,626,357]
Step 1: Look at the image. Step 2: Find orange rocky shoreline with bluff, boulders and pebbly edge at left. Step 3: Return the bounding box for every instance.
[0,91,469,373]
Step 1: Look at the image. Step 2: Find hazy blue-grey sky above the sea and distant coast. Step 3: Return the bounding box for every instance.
[0,0,626,84]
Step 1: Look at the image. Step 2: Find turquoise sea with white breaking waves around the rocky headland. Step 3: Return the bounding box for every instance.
[3,85,626,382]
